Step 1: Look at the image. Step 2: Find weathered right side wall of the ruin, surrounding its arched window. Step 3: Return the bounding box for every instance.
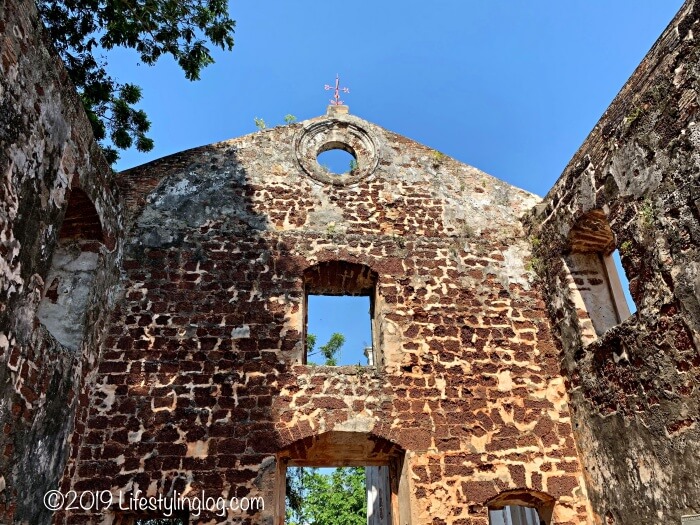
[530,0,700,525]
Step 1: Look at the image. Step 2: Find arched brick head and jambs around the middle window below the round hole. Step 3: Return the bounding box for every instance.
[298,260,384,368]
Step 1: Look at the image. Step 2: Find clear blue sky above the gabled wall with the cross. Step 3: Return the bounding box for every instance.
[109,0,682,364]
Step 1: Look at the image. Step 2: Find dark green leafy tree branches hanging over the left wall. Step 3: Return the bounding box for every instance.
[37,0,235,164]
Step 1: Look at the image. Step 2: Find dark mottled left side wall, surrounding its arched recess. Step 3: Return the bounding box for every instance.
[0,0,120,524]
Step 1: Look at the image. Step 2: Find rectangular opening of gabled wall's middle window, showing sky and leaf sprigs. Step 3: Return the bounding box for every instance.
[306,294,375,366]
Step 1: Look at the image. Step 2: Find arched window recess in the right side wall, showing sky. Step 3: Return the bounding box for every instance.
[563,209,630,344]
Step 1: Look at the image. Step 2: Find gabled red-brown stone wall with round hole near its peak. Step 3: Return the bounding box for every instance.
[64,116,587,525]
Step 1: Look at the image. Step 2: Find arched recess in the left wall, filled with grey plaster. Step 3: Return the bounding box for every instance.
[37,187,114,350]
